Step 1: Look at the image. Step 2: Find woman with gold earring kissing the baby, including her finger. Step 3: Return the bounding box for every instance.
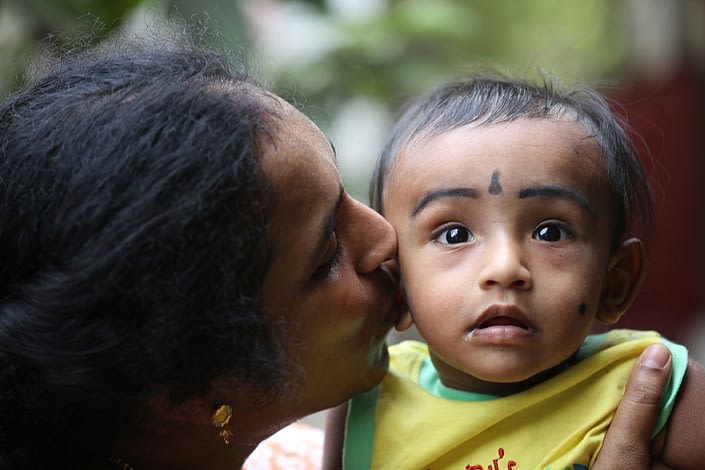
[0,30,668,470]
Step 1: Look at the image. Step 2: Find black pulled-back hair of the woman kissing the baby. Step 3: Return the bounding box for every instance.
[0,31,285,469]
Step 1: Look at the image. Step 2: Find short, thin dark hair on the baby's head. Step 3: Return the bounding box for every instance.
[370,71,653,243]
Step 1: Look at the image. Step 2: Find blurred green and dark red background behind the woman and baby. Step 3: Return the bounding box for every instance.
[0,0,705,352]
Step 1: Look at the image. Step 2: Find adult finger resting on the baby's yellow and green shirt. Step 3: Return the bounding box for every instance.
[593,344,671,470]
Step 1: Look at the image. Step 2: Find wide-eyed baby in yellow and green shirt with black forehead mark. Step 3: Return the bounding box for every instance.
[325,74,705,470]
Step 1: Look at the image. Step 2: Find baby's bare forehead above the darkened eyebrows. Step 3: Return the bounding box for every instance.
[385,119,607,192]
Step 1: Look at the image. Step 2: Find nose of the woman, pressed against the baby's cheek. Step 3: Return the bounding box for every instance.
[339,198,397,273]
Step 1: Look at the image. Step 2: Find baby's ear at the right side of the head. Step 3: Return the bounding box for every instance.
[597,238,646,325]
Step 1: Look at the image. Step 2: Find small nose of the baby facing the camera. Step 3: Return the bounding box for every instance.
[479,236,531,289]
